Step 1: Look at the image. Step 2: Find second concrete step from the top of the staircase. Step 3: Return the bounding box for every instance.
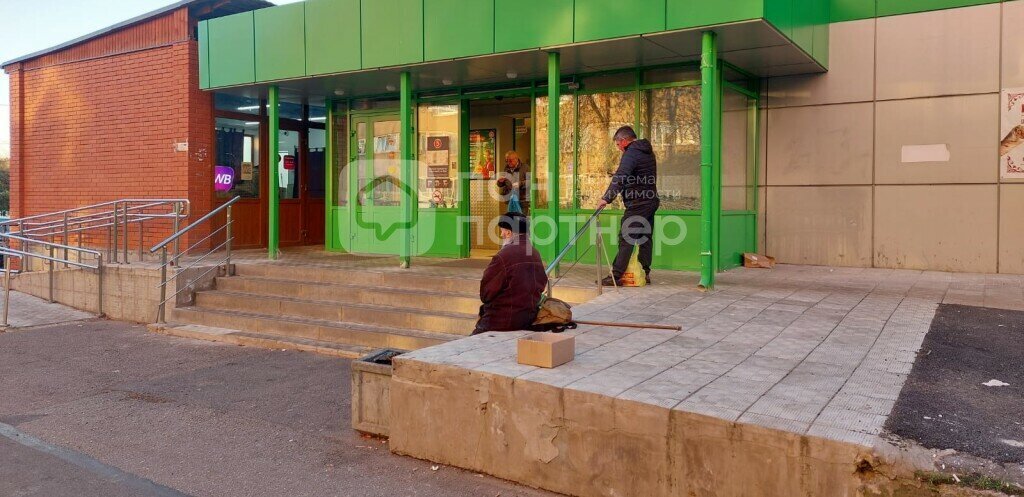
[216,276,480,316]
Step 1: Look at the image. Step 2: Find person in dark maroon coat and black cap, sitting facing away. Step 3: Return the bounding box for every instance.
[473,212,548,335]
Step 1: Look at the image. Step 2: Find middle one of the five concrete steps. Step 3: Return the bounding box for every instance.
[196,290,476,335]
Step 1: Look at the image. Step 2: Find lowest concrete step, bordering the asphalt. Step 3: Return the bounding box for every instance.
[148,324,373,359]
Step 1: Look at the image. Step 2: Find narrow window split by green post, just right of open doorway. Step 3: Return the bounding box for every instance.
[534,95,575,209]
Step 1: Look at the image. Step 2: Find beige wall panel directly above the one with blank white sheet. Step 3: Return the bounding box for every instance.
[876,3,999,100]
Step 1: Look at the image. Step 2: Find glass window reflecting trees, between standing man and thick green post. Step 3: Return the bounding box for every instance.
[640,86,700,210]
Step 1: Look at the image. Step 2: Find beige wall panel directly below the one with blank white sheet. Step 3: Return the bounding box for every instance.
[872,184,998,273]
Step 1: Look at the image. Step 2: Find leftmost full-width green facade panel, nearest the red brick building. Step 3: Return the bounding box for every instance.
[207,12,256,87]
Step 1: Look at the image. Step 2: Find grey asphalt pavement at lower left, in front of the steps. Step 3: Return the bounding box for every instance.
[0,320,553,497]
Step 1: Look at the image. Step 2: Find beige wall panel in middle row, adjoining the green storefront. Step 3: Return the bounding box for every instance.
[766,102,872,185]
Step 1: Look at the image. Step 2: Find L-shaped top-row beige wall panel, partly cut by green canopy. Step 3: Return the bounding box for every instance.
[767,18,874,107]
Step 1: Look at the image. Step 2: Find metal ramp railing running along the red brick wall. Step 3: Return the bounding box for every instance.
[0,199,190,272]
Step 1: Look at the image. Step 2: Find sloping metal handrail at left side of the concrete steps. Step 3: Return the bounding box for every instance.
[150,197,242,323]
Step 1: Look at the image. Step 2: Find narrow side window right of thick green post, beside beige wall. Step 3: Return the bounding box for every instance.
[722,89,757,211]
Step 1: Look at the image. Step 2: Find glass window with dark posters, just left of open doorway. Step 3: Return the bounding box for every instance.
[417,103,460,208]
